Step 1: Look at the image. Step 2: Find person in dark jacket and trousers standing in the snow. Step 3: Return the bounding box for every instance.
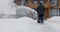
[37,3,45,23]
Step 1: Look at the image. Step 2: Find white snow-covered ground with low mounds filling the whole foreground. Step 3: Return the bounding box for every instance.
[0,16,60,32]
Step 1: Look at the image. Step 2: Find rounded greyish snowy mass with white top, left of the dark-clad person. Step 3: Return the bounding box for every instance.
[16,6,37,19]
